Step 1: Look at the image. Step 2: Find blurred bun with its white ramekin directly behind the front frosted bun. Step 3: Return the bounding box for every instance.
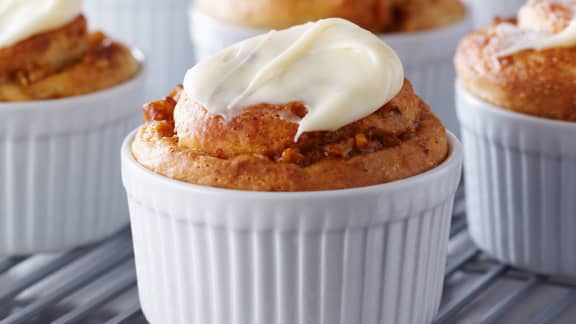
[190,0,472,133]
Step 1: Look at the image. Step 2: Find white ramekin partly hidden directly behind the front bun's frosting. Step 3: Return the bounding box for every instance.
[189,5,473,134]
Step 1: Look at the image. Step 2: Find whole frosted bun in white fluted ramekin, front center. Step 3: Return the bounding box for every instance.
[122,18,461,324]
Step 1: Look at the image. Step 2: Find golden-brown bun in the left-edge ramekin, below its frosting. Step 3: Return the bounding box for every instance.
[0,16,140,102]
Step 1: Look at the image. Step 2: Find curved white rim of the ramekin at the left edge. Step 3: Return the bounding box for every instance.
[0,47,148,113]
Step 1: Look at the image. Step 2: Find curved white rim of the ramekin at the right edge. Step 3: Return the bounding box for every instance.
[455,78,576,131]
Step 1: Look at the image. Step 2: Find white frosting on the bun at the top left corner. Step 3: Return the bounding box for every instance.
[0,0,84,47]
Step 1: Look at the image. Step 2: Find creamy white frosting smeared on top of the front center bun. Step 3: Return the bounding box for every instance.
[182,18,404,139]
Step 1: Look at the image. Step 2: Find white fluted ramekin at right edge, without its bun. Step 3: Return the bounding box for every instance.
[456,84,576,277]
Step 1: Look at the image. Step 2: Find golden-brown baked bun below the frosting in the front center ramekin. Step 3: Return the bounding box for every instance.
[132,82,448,191]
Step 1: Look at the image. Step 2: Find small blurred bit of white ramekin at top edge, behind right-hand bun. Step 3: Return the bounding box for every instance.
[467,0,528,27]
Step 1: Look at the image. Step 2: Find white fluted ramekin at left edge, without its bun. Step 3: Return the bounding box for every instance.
[0,52,146,255]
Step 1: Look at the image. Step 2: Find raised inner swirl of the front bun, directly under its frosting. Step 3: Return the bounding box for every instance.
[175,82,422,160]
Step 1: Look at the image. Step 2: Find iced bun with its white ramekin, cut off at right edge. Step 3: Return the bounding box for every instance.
[456,0,576,277]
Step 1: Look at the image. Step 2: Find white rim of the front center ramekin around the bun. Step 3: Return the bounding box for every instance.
[121,128,463,200]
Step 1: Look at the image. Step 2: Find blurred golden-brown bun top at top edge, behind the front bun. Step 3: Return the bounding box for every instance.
[197,0,466,32]
